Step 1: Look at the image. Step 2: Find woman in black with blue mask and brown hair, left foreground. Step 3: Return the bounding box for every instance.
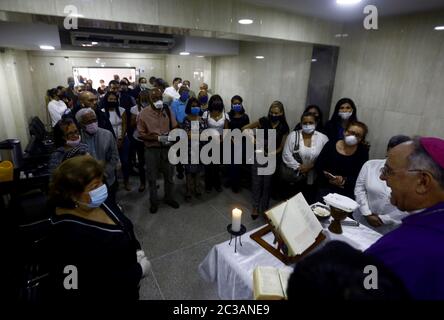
[50,155,150,301]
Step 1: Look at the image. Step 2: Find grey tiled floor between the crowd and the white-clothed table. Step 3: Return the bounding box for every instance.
[117,172,265,300]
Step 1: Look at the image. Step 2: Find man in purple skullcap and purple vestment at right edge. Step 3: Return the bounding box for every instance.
[367,137,444,300]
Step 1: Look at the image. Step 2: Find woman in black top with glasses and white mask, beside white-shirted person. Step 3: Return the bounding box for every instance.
[315,121,369,201]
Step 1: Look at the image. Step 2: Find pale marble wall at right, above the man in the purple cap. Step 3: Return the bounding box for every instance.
[331,12,444,158]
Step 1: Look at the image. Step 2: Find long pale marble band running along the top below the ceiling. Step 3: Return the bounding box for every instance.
[0,0,342,45]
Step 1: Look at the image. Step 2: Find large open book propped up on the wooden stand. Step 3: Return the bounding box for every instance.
[265,193,322,256]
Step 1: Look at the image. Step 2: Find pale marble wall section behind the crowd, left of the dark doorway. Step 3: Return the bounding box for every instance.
[214,42,313,128]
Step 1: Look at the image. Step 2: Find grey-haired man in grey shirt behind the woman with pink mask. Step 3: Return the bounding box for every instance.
[76,108,119,200]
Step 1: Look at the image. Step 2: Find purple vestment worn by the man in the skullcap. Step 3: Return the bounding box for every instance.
[366,202,444,300]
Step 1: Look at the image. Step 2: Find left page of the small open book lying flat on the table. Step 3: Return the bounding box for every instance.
[253,267,284,300]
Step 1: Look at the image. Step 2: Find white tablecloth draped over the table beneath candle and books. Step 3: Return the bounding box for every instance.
[199,218,382,300]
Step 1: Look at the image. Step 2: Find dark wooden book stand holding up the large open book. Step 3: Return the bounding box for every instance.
[250,222,325,265]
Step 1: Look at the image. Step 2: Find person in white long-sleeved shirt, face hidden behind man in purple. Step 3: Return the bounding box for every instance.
[353,135,411,234]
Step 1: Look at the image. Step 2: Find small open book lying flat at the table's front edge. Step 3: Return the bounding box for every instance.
[253,266,291,300]
